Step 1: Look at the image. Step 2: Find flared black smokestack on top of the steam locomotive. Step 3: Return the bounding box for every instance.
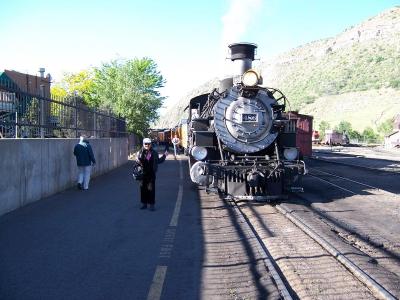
[228,43,257,75]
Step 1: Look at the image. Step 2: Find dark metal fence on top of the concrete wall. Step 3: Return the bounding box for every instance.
[0,81,127,138]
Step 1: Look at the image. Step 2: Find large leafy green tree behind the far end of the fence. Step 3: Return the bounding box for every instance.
[94,58,165,136]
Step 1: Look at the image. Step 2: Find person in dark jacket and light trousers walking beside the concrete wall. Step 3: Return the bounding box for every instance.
[74,135,96,190]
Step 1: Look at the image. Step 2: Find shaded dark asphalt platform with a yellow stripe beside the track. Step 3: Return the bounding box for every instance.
[0,155,203,299]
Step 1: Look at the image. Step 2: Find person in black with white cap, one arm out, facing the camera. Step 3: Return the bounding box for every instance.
[136,138,168,211]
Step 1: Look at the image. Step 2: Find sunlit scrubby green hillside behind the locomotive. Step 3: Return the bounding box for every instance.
[160,7,400,130]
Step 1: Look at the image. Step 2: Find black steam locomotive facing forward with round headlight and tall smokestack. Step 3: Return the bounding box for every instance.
[188,43,306,201]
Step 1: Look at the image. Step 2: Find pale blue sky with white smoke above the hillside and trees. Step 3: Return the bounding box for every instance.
[0,0,400,108]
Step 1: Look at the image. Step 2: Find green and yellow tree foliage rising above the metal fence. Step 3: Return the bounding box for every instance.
[51,58,165,135]
